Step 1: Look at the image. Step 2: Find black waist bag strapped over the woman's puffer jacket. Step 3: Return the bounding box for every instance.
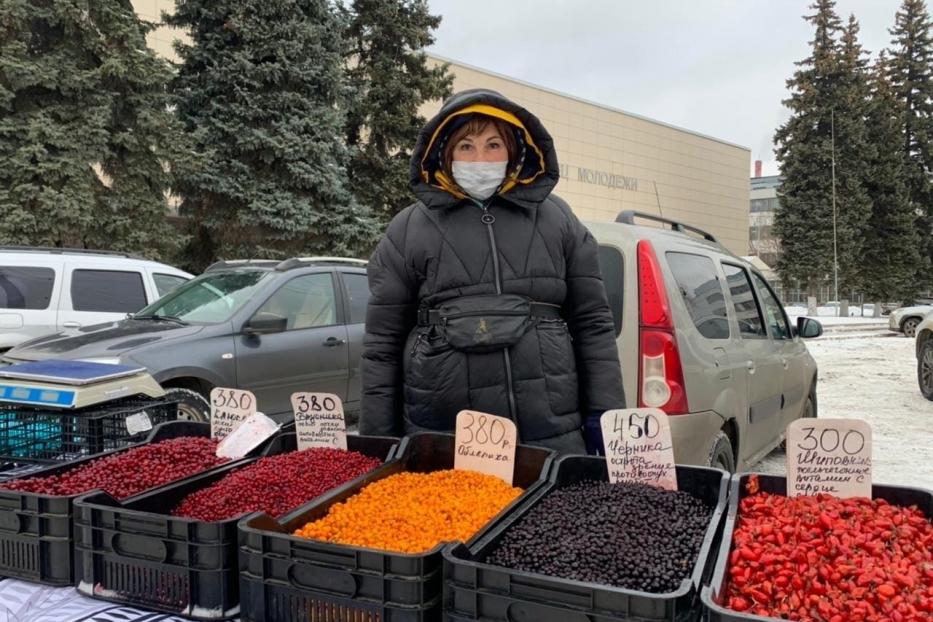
[420,294,560,352]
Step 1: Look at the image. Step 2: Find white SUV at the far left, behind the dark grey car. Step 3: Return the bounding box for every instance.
[0,246,191,352]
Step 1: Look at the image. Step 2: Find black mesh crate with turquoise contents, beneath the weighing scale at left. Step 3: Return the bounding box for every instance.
[0,398,178,463]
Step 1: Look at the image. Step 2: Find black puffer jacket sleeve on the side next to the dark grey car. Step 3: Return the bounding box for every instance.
[360,212,417,436]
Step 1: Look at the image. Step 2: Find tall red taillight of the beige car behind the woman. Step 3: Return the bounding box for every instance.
[638,240,690,415]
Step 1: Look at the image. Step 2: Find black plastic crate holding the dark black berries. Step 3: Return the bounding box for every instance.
[444,456,729,622]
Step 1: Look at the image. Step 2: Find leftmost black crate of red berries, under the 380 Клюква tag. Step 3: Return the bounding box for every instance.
[0,421,222,585]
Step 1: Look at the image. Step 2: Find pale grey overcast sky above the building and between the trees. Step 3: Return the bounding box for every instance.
[429,0,900,175]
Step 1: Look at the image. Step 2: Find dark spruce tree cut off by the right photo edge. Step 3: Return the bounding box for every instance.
[886,0,933,294]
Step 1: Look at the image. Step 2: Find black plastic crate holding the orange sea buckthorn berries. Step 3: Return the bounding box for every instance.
[240,433,553,622]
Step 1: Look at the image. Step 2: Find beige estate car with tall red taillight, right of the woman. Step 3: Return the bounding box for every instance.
[587,212,822,470]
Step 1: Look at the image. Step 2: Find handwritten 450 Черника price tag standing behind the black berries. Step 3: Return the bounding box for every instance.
[599,408,677,490]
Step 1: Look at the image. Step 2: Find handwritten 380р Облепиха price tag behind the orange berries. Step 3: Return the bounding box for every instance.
[454,410,518,484]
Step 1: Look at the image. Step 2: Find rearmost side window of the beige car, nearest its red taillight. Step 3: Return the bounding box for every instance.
[667,253,730,339]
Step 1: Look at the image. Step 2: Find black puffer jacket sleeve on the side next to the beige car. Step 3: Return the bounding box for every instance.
[564,204,625,413]
